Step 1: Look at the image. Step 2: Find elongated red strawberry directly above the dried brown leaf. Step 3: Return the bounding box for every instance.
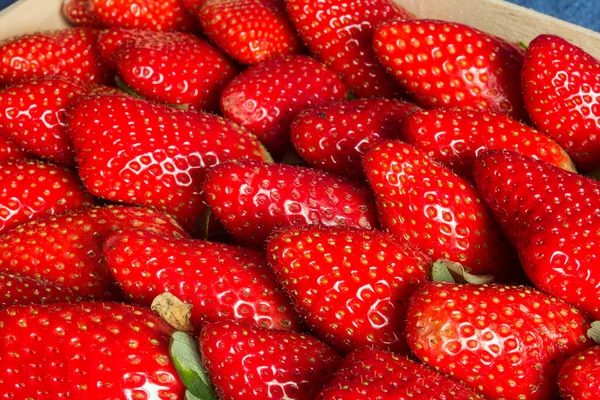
[104,231,298,332]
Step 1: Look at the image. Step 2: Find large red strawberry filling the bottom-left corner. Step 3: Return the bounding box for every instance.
[0,303,185,400]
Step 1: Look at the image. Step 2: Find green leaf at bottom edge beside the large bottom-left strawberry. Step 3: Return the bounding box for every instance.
[169,332,216,400]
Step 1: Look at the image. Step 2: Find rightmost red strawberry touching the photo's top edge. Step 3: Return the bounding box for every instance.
[286,0,410,97]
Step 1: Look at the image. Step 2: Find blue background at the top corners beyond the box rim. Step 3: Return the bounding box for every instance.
[0,0,600,32]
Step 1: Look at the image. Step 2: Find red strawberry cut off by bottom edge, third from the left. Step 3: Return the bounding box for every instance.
[318,348,482,400]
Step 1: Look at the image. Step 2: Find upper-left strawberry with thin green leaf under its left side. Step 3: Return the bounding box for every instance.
[98,29,236,109]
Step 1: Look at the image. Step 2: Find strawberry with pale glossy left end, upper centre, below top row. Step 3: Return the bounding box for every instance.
[221,56,346,157]
